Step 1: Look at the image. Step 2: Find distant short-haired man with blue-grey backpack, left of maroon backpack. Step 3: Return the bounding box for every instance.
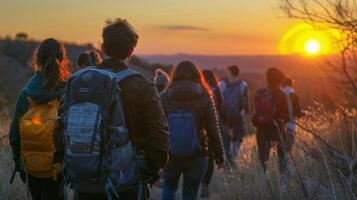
[221,65,249,166]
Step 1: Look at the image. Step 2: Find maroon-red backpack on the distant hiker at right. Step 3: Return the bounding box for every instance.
[252,88,275,127]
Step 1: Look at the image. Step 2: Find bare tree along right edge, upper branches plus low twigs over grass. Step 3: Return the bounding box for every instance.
[280,0,357,192]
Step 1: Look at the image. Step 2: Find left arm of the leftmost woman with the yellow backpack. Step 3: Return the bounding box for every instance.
[9,90,29,171]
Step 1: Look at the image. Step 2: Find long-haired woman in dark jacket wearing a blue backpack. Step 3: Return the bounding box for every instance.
[161,61,224,200]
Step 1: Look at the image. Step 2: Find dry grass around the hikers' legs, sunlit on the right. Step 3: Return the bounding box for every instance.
[0,104,357,200]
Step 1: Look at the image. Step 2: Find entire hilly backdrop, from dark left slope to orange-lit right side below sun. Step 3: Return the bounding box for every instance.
[0,39,338,107]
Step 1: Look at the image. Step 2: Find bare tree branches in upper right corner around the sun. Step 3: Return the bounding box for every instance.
[280,0,357,96]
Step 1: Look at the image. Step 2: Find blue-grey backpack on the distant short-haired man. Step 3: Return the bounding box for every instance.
[223,81,247,119]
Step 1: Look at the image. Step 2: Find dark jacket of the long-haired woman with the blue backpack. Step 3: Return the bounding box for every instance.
[161,81,224,164]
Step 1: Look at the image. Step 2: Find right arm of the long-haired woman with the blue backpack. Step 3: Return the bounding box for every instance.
[205,96,224,165]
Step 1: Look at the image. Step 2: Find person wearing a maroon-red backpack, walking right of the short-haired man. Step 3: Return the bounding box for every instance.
[252,68,289,174]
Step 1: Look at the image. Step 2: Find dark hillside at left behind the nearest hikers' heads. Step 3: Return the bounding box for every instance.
[0,39,155,104]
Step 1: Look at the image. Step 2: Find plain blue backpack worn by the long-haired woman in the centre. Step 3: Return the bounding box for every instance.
[168,108,201,157]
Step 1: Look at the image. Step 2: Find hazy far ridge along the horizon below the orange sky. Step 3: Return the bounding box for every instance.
[139,54,324,76]
